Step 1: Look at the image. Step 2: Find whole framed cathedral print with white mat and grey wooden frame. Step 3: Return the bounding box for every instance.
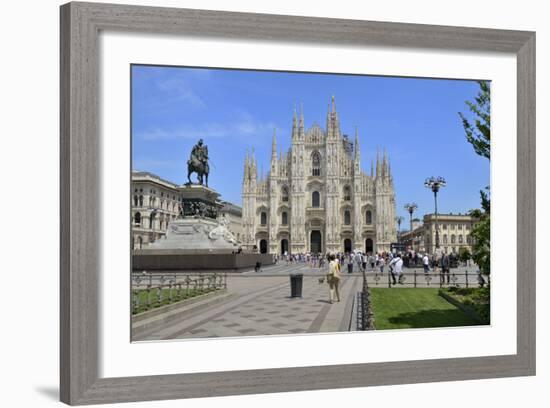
[61,3,535,404]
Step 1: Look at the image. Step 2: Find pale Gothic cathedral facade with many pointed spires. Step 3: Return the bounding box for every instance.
[242,97,397,254]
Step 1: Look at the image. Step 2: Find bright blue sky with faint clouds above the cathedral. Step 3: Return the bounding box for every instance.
[132,65,489,229]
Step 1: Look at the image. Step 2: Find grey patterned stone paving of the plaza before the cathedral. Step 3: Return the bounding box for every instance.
[133,262,477,341]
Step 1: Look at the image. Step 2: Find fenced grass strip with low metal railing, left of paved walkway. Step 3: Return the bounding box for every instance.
[132,271,227,314]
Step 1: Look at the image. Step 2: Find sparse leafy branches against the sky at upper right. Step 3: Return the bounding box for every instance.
[459,81,491,159]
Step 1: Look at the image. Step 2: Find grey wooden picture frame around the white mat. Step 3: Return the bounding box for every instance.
[60,3,535,405]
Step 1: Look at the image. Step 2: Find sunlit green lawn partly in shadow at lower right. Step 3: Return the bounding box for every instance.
[370,288,479,330]
